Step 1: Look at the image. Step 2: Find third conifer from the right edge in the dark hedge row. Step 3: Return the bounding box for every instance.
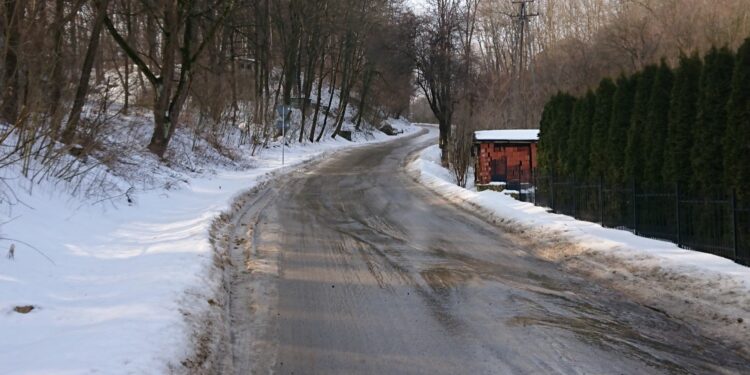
[664,54,703,186]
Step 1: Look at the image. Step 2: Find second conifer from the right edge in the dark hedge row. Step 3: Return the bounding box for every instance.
[692,48,734,192]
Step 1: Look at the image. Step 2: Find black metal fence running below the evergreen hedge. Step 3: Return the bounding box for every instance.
[520,174,750,266]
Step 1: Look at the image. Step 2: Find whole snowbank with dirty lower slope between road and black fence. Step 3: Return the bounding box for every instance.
[408,140,750,350]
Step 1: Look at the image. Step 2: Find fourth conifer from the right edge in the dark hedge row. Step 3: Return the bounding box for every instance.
[643,60,673,186]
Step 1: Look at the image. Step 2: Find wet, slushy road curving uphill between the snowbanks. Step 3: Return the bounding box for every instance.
[226,129,750,374]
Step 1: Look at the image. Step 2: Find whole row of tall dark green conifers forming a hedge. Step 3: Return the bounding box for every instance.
[539,38,750,199]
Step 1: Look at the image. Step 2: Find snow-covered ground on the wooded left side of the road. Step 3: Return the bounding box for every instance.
[0,116,419,374]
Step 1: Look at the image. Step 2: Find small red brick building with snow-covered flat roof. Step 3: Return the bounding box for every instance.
[472,129,539,190]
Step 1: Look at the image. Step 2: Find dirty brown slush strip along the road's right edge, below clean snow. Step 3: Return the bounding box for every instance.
[402,142,750,358]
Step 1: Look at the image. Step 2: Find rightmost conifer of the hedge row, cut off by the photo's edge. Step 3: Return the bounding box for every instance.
[724,38,750,202]
